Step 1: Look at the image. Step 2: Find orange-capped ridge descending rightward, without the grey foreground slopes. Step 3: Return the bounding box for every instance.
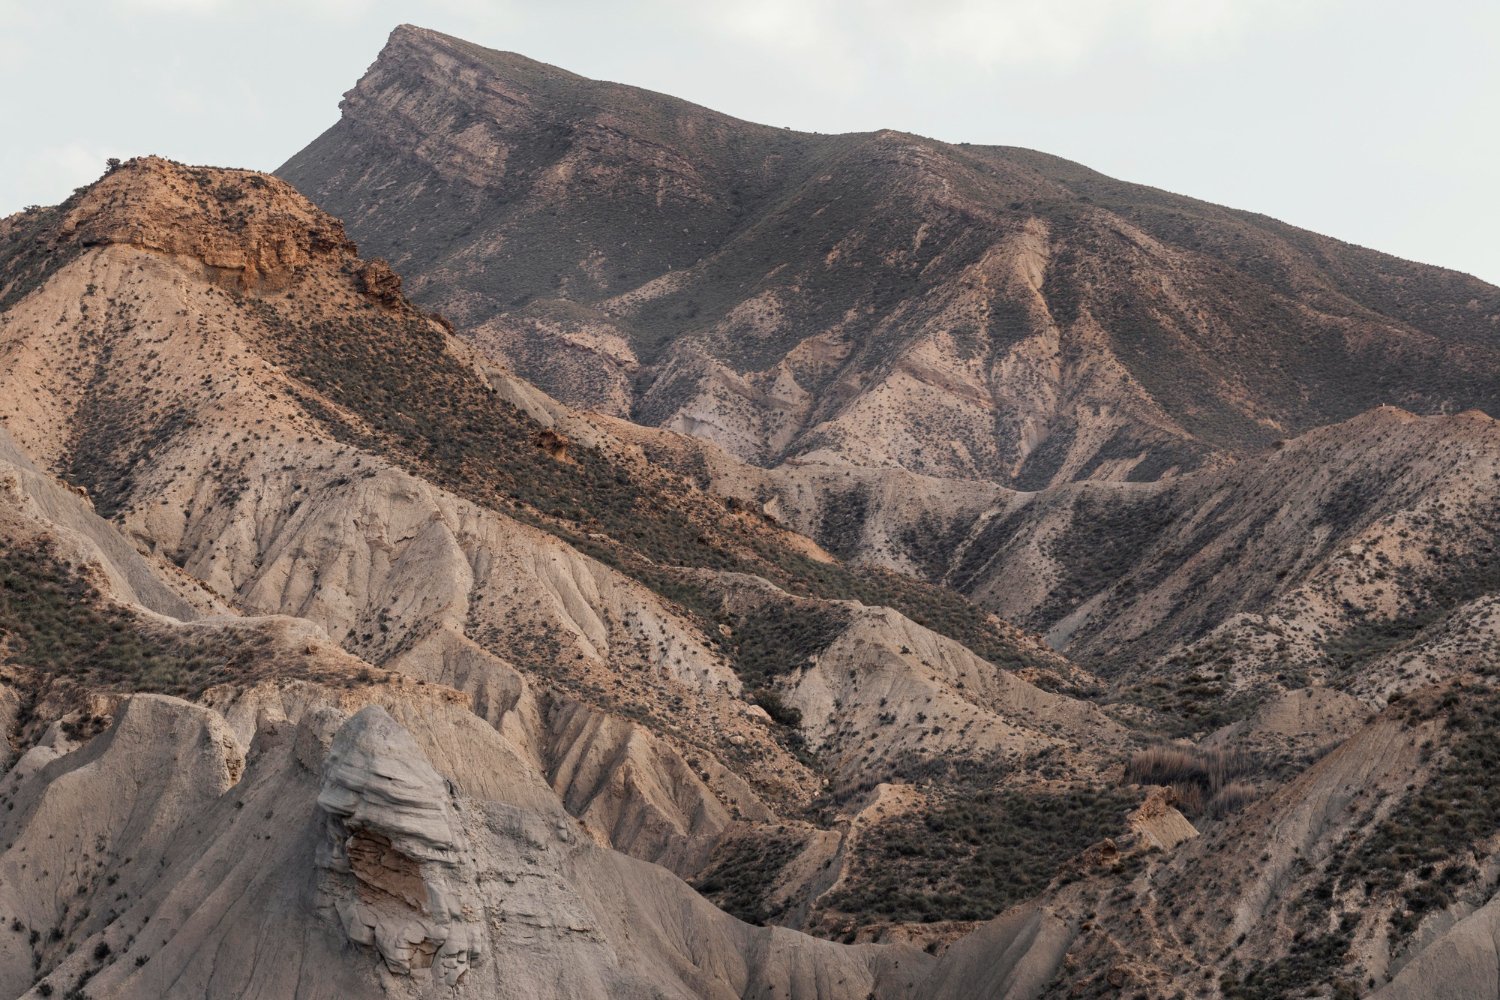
[0,159,1133,953]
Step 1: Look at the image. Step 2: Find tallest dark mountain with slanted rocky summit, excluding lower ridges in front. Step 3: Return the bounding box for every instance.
[278,27,1500,490]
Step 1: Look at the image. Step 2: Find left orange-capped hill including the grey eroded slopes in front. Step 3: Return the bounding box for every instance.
[0,157,1164,997]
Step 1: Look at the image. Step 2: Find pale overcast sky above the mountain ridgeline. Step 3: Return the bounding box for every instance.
[0,0,1500,283]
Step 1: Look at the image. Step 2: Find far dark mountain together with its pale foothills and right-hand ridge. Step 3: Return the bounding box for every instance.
[281,27,1500,720]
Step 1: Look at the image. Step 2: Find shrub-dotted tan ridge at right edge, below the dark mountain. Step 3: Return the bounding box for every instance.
[944,408,1500,675]
